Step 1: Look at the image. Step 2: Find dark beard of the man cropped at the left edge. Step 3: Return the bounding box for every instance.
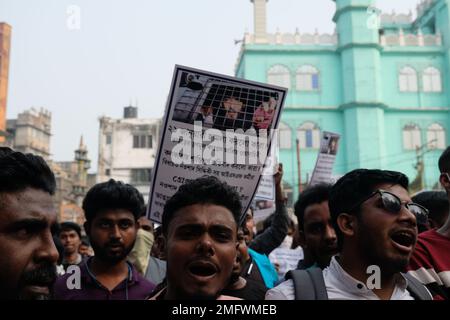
[17,264,57,300]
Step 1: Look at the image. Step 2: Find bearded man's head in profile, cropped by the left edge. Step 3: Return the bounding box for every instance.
[0,148,58,300]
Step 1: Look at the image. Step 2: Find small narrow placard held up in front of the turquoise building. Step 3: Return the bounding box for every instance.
[309,131,340,186]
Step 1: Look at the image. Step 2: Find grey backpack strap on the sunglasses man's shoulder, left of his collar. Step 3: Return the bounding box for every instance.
[286,268,328,300]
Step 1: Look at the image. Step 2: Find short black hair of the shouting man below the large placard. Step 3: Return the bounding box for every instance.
[162,176,242,235]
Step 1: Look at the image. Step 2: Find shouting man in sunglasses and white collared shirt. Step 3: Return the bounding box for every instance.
[266,169,431,300]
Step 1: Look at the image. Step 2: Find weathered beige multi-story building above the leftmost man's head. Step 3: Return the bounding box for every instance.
[6,108,52,160]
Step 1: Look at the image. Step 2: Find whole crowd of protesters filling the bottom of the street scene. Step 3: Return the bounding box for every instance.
[0,147,450,300]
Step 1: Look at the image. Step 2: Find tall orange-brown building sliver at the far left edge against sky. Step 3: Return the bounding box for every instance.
[0,22,11,143]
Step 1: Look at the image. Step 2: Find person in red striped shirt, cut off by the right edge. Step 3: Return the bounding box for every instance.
[409,147,450,300]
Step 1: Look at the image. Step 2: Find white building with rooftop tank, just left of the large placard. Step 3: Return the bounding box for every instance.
[97,106,161,202]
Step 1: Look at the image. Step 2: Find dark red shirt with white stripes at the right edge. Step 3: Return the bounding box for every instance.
[408,230,450,300]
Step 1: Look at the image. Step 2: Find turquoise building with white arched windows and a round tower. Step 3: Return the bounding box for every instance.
[235,0,450,198]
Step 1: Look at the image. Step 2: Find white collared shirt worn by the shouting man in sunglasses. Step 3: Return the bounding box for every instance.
[266,257,414,300]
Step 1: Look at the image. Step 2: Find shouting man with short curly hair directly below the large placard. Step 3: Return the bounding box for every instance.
[152,177,241,300]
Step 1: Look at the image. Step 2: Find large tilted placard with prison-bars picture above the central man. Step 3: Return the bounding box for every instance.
[147,66,287,223]
